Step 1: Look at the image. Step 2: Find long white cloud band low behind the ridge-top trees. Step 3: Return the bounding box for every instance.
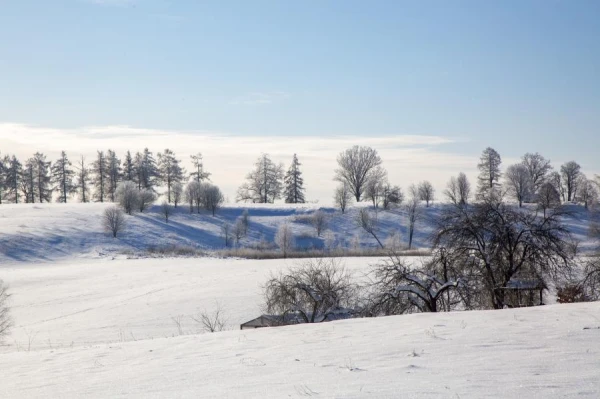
[0,123,478,202]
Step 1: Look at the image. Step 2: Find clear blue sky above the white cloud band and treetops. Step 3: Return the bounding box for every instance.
[0,0,600,200]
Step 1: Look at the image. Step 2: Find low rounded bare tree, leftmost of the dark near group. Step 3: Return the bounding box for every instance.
[263,258,356,323]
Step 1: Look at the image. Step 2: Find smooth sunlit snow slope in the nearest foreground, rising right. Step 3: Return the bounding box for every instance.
[0,303,600,398]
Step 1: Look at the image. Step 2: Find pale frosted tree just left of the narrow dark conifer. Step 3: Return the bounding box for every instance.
[237,154,283,204]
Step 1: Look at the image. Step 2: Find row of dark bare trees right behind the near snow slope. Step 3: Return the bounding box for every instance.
[263,195,600,323]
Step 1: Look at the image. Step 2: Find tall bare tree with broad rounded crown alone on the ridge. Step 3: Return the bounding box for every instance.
[335,145,382,202]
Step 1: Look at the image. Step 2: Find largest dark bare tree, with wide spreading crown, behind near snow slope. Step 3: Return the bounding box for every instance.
[433,197,574,309]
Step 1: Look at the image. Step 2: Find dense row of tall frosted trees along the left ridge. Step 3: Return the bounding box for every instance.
[0,148,210,204]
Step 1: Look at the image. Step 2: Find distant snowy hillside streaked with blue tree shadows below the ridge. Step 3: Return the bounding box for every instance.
[0,203,593,261]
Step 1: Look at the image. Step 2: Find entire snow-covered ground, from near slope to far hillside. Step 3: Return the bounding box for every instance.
[0,204,600,398]
